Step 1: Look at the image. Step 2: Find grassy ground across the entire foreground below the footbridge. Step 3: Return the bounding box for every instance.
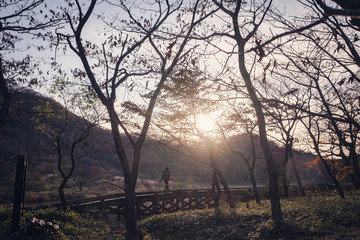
[0,191,360,240]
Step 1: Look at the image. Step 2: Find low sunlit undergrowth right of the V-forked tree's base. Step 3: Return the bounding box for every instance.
[140,192,360,240]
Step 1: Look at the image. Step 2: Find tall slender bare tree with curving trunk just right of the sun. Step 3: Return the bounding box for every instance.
[208,0,283,225]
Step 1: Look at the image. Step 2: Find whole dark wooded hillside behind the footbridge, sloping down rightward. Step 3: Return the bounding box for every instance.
[0,91,321,203]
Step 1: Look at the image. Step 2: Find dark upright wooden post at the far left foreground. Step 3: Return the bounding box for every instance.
[11,155,26,232]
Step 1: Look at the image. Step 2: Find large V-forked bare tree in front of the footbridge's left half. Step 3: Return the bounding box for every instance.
[58,0,214,239]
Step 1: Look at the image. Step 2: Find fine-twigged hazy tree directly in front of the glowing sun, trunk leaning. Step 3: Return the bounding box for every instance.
[155,67,235,208]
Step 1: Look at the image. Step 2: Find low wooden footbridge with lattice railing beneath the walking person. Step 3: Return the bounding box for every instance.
[25,187,249,217]
